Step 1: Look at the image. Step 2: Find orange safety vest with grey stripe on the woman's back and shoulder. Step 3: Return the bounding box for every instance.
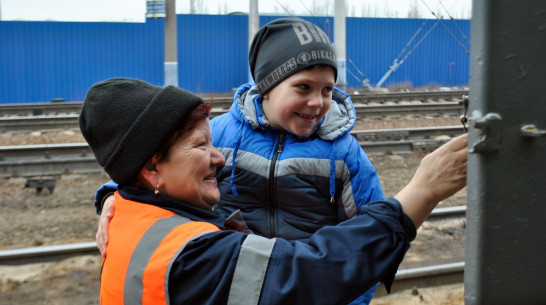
[100,192,220,305]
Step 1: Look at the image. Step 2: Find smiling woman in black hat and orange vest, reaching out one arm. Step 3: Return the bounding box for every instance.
[80,78,467,304]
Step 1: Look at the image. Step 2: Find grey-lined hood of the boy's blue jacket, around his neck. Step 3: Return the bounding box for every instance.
[230,83,356,141]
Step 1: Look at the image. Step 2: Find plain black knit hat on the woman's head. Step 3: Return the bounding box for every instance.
[79,78,203,184]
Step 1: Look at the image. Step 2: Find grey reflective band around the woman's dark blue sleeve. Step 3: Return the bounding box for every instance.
[228,234,275,305]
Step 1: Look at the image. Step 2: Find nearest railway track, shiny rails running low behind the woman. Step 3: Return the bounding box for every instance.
[0,206,466,296]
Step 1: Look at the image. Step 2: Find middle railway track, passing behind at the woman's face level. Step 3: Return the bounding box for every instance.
[0,125,463,178]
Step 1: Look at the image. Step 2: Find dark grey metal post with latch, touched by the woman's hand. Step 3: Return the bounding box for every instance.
[464,0,546,305]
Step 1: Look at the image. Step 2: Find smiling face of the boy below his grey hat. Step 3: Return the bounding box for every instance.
[262,66,335,136]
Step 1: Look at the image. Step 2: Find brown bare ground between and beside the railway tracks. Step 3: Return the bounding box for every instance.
[0,117,465,305]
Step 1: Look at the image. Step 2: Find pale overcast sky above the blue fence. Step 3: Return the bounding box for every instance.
[0,0,472,22]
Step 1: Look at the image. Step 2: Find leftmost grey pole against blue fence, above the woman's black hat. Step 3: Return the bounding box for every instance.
[164,0,178,86]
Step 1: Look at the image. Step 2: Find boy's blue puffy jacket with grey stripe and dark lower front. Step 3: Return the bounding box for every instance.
[211,84,384,241]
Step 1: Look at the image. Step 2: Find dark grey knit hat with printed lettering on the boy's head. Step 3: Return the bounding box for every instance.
[248,18,337,95]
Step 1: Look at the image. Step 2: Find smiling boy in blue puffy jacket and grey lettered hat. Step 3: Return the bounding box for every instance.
[211,18,384,304]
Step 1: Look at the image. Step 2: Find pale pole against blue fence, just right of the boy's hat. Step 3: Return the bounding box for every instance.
[334,0,347,89]
